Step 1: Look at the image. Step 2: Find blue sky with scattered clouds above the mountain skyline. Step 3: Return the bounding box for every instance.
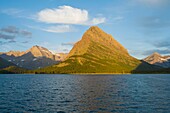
[0,0,170,59]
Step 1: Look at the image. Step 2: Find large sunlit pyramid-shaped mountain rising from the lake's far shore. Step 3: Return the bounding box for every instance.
[36,26,160,73]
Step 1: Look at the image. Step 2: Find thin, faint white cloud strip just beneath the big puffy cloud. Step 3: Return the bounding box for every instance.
[42,25,76,33]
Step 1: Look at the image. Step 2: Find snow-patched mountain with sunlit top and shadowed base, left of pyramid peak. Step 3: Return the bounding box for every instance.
[0,45,67,70]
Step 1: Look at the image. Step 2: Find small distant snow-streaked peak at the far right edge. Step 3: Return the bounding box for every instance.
[143,52,170,68]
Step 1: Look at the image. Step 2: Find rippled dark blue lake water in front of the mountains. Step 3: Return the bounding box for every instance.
[0,74,170,113]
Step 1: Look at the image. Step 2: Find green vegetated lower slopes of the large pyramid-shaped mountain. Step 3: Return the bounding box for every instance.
[35,42,158,74]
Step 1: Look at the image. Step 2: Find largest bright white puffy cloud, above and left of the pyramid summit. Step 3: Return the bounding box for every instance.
[37,6,105,25]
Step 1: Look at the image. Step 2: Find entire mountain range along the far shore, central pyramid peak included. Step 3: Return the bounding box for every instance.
[0,26,170,74]
